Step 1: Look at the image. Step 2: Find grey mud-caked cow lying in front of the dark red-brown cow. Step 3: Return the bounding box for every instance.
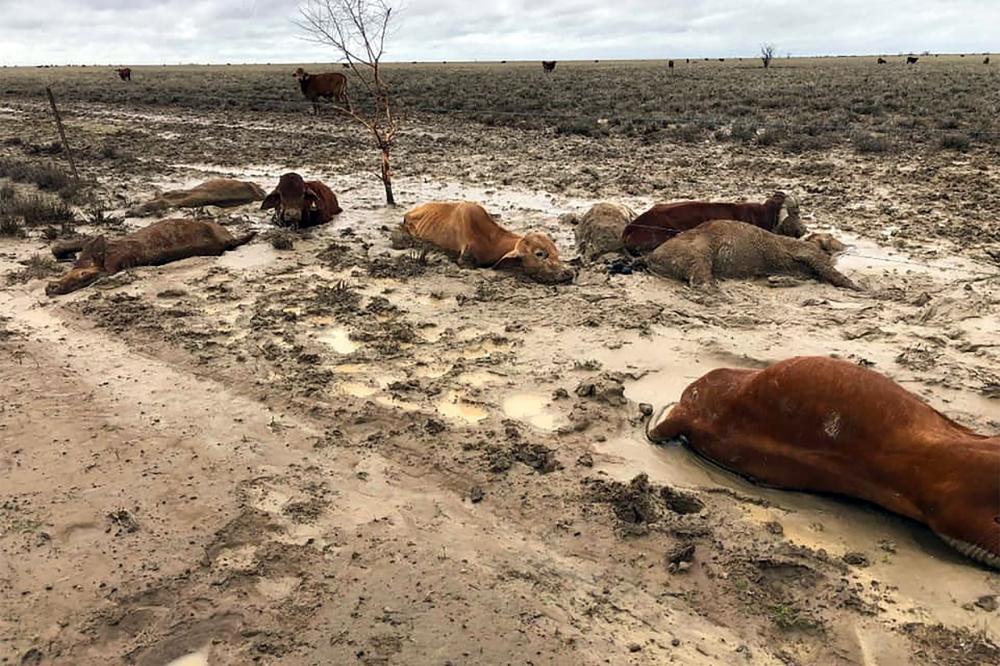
[646,220,860,290]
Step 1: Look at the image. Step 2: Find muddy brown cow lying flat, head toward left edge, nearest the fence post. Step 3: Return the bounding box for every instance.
[45,219,255,296]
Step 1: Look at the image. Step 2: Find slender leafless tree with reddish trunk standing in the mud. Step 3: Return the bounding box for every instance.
[295,0,401,206]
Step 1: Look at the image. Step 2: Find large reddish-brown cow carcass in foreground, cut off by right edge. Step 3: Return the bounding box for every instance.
[649,357,1000,568]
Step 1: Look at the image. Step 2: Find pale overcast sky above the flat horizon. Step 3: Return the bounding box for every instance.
[0,0,1000,65]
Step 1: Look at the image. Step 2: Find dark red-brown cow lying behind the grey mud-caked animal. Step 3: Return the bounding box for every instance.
[622,192,806,252]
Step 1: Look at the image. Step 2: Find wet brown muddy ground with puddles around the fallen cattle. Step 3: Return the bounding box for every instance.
[0,59,1000,666]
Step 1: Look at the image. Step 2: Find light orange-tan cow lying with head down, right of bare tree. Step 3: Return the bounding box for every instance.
[393,201,574,282]
